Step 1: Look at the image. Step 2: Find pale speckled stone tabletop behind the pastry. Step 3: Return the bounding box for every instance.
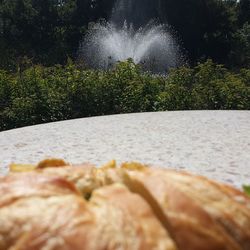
[0,111,250,187]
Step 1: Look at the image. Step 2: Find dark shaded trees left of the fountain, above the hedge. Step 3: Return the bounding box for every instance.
[0,0,107,68]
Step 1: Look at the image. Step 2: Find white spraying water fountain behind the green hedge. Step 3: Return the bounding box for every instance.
[80,0,182,72]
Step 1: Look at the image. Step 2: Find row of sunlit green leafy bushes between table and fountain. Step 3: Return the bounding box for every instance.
[0,60,250,130]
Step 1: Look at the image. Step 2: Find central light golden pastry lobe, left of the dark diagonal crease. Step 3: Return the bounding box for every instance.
[90,184,177,250]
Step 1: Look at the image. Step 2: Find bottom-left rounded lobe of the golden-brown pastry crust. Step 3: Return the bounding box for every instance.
[0,195,99,250]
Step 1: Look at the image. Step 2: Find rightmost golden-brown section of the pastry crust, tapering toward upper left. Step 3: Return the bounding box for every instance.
[148,170,250,250]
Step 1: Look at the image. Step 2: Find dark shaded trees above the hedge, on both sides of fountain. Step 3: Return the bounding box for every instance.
[0,0,250,70]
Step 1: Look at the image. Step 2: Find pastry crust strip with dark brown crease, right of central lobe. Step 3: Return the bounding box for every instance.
[122,170,240,250]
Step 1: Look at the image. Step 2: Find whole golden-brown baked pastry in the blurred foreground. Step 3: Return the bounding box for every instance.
[0,160,250,250]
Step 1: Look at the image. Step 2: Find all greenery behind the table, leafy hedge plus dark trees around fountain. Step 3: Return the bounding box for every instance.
[0,0,250,130]
